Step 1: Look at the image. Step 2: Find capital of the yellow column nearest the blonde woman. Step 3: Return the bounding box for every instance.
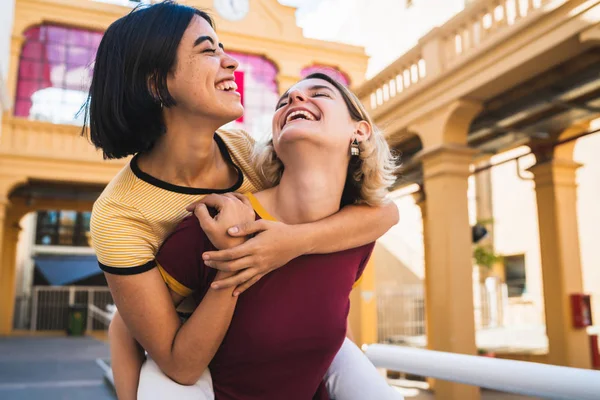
[415,143,477,180]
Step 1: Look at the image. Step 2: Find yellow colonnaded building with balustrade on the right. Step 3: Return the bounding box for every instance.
[358,0,600,399]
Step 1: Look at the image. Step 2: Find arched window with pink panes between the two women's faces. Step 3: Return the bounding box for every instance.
[229,52,279,140]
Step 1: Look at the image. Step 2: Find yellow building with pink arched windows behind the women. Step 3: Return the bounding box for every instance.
[0,0,367,335]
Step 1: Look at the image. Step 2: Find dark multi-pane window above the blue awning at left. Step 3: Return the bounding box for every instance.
[35,210,91,247]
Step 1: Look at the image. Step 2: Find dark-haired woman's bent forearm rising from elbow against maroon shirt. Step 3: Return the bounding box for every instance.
[164,272,238,385]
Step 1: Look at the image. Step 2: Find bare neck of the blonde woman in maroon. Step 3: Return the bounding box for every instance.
[257,158,347,224]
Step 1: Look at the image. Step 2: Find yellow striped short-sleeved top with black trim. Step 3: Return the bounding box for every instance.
[90,129,264,275]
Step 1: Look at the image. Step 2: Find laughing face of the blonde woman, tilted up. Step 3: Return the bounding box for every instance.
[273,79,357,161]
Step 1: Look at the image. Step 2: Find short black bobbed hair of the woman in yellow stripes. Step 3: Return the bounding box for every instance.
[82,1,214,159]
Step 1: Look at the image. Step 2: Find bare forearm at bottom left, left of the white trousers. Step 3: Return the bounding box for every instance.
[108,312,144,400]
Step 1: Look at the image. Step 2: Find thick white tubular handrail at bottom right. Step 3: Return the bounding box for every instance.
[364,344,600,400]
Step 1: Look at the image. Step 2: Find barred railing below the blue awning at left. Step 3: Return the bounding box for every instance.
[29,286,113,331]
